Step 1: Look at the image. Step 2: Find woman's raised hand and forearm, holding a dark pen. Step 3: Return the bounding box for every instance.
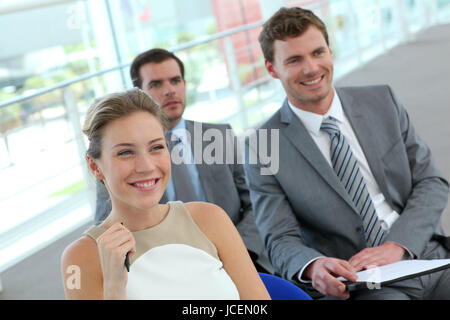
[97,223,136,299]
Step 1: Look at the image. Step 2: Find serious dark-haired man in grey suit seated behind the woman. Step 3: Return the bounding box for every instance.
[95,49,272,272]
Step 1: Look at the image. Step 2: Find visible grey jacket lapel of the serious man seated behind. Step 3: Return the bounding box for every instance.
[184,120,214,202]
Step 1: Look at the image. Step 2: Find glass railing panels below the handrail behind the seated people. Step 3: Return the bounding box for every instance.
[0,0,450,272]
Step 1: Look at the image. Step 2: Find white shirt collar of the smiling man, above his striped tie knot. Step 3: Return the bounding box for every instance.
[288,88,344,135]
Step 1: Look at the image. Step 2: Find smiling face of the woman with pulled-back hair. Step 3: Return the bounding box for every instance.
[87,111,170,218]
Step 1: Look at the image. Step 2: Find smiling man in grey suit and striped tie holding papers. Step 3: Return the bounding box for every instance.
[245,8,450,299]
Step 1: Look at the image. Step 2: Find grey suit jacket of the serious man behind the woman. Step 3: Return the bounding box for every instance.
[95,120,271,270]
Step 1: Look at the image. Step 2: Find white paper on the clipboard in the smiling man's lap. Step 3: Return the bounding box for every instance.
[338,259,450,291]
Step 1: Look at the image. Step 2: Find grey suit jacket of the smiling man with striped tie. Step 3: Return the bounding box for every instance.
[245,86,449,281]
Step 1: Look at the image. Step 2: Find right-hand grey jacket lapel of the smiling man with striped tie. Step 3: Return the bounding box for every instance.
[336,88,392,204]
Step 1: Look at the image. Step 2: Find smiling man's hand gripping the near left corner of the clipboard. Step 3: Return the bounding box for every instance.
[304,258,358,299]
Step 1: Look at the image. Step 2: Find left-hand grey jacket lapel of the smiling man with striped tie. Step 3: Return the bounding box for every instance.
[280,100,357,213]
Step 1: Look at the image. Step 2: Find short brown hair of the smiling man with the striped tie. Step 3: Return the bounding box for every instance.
[258,7,330,62]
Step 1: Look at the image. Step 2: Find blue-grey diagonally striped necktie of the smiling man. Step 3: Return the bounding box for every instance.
[320,118,384,247]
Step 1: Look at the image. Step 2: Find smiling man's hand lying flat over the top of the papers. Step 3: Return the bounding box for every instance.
[349,242,405,272]
